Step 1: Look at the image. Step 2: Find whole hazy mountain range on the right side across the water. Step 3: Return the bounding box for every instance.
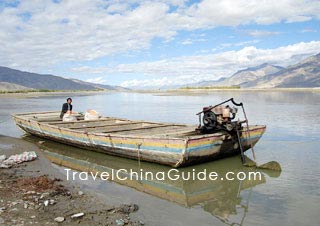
[184,53,320,88]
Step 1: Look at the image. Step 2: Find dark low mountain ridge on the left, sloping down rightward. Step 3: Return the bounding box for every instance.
[0,67,124,90]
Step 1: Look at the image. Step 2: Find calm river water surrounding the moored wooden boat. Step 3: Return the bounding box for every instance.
[0,92,320,225]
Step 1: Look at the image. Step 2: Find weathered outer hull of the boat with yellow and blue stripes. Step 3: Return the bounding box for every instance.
[13,113,266,167]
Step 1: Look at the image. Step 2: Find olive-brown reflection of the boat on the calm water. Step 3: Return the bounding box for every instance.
[23,135,280,225]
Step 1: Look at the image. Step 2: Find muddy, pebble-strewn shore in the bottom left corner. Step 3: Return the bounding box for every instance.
[0,135,144,226]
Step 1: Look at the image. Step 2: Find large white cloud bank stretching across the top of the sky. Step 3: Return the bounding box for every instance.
[0,0,320,71]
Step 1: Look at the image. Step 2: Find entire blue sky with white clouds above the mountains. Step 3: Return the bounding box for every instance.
[0,0,320,87]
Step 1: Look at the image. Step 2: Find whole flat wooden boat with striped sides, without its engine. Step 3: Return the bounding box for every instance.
[12,111,266,167]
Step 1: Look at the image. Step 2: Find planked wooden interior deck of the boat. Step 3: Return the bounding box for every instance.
[16,112,200,137]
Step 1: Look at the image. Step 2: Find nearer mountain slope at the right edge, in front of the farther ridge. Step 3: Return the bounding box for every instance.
[249,53,320,88]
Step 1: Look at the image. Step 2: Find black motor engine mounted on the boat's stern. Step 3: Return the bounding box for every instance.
[199,105,241,133]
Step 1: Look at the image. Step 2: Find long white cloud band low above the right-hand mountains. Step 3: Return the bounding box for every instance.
[119,41,320,87]
